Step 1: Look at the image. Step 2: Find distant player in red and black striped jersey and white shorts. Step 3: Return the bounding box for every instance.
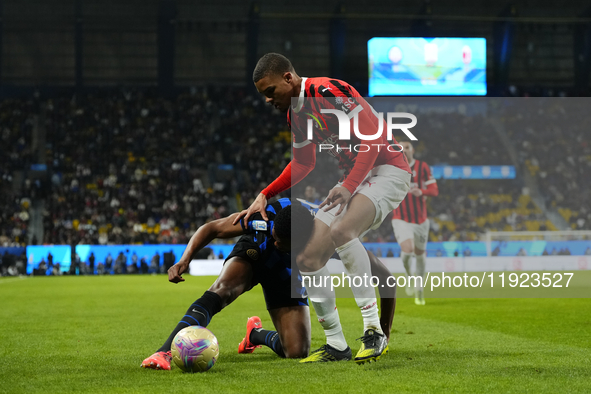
[392,141,439,305]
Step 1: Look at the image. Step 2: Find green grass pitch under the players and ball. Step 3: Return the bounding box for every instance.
[0,275,591,393]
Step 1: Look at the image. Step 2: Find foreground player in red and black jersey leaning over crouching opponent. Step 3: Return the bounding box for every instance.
[236,53,410,363]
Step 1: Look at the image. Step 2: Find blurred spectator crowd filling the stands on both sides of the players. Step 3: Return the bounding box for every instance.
[0,87,591,252]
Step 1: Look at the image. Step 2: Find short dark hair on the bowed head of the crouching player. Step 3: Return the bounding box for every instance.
[275,201,314,252]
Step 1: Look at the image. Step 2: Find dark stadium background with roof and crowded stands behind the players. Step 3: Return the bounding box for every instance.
[0,0,591,275]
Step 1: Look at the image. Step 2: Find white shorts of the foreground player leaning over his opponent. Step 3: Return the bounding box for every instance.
[316,164,411,230]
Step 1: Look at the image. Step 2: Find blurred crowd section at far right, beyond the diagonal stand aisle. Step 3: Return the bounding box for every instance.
[506,97,591,230]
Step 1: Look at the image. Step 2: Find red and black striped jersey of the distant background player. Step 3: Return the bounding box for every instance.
[392,160,439,224]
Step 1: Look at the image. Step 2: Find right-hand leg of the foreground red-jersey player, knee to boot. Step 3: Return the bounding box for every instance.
[330,193,387,363]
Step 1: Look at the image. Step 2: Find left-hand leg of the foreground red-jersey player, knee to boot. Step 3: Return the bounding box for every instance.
[296,220,351,362]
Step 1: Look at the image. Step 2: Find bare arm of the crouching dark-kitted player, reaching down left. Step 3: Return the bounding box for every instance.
[168,213,244,283]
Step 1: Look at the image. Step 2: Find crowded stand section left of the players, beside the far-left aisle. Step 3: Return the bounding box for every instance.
[44,89,289,244]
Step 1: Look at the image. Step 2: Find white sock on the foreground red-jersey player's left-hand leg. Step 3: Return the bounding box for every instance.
[300,265,348,350]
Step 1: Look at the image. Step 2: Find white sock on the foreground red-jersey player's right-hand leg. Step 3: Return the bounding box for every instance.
[336,238,382,333]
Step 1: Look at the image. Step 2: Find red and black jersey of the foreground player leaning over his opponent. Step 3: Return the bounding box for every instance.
[287,77,410,189]
